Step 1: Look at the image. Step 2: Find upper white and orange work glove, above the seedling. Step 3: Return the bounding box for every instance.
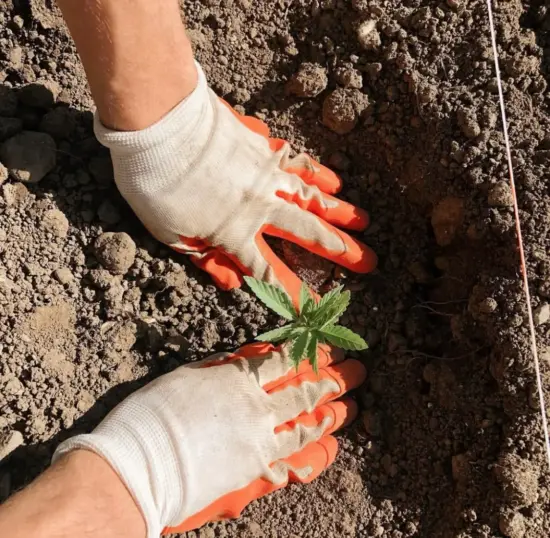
[95,62,376,301]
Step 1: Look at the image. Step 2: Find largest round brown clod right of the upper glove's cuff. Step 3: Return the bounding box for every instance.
[323,88,369,135]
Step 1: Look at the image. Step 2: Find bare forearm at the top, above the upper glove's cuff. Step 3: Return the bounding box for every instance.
[58,0,197,130]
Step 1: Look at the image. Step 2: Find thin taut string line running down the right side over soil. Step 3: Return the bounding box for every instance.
[487,0,550,467]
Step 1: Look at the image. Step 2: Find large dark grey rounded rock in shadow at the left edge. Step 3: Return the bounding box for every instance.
[0,131,56,183]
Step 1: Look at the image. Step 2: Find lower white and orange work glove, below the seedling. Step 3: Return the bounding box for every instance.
[54,343,366,538]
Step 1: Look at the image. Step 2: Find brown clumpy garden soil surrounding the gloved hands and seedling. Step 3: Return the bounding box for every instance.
[0,0,550,538]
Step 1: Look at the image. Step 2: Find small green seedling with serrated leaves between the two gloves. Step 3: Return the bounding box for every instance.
[244,277,368,372]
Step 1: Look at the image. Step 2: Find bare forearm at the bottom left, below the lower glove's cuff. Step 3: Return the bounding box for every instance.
[0,451,146,538]
